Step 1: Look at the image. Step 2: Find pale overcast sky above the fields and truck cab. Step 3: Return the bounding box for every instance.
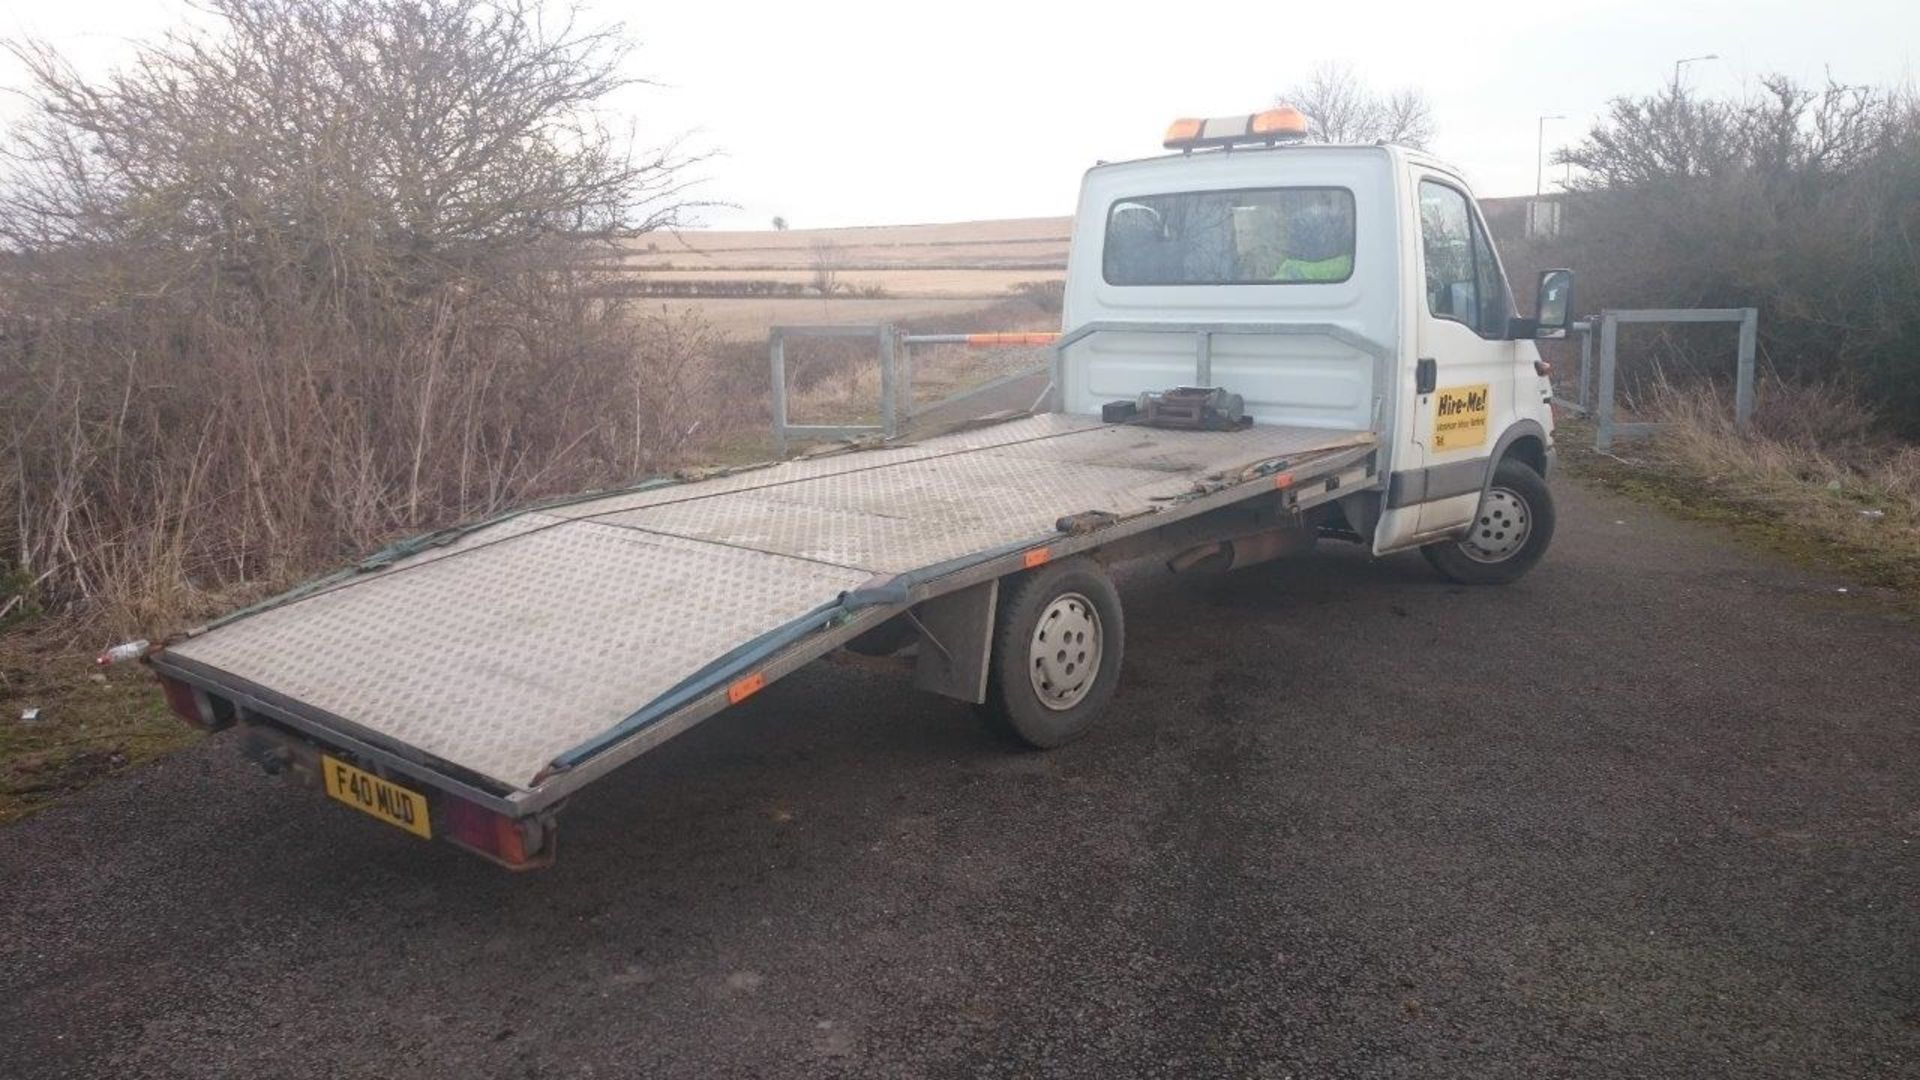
[0,0,1920,229]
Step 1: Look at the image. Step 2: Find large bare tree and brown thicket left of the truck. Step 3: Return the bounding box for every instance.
[0,0,708,628]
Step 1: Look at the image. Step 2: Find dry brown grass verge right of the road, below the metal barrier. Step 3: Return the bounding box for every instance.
[1590,380,1920,607]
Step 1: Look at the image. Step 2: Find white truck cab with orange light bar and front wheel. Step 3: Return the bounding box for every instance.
[1054,108,1572,580]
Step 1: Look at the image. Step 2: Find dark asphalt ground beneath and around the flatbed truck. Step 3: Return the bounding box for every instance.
[0,480,1920,1078]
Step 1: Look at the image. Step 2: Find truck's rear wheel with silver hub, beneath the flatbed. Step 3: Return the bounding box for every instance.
[981,559,1127,749]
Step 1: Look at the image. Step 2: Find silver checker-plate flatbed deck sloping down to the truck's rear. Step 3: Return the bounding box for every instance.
[165,413,1373,794]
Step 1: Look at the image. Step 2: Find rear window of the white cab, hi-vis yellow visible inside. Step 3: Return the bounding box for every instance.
[1100,188,1354,284]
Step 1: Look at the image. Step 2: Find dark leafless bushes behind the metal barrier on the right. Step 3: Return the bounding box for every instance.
[1515,77,1920,436]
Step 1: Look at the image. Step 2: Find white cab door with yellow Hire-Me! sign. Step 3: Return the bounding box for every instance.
[1409,171,1515,538]
